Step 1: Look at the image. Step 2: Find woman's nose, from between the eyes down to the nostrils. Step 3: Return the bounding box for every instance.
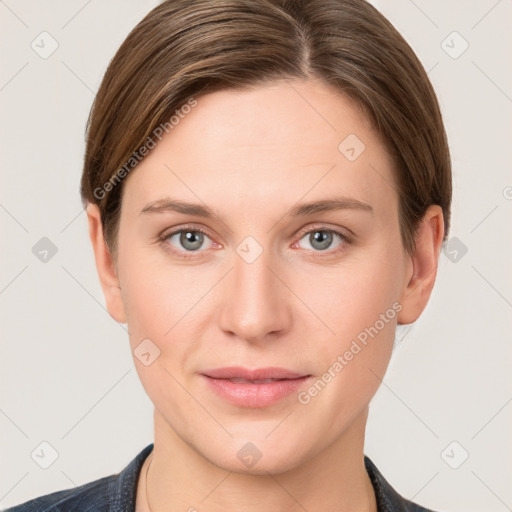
[219,244,293,344]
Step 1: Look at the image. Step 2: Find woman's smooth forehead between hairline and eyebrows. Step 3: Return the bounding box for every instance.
[123,80,397,219]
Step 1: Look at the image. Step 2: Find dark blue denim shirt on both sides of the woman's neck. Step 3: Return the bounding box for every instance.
[5,443,434,512]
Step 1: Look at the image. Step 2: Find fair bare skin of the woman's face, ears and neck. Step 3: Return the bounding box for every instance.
[87,80,443,512]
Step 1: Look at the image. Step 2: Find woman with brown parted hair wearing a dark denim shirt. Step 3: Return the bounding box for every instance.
[6,0,451,512]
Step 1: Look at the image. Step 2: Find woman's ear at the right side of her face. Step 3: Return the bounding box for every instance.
[397,205,444,324]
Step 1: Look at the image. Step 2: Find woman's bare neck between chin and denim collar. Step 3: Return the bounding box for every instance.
[136,409,377,512]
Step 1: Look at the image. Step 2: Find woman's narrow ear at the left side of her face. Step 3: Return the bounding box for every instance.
[85,203,126,324]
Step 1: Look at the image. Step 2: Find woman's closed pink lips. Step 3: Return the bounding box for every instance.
[200,366,311,408]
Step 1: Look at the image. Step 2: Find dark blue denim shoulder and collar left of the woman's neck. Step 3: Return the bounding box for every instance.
[4,444,153,512]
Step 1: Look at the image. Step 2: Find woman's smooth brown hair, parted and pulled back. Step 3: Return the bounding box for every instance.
[80,0,452,254]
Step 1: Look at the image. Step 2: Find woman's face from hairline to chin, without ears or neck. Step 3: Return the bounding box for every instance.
[94,81,426,473]
